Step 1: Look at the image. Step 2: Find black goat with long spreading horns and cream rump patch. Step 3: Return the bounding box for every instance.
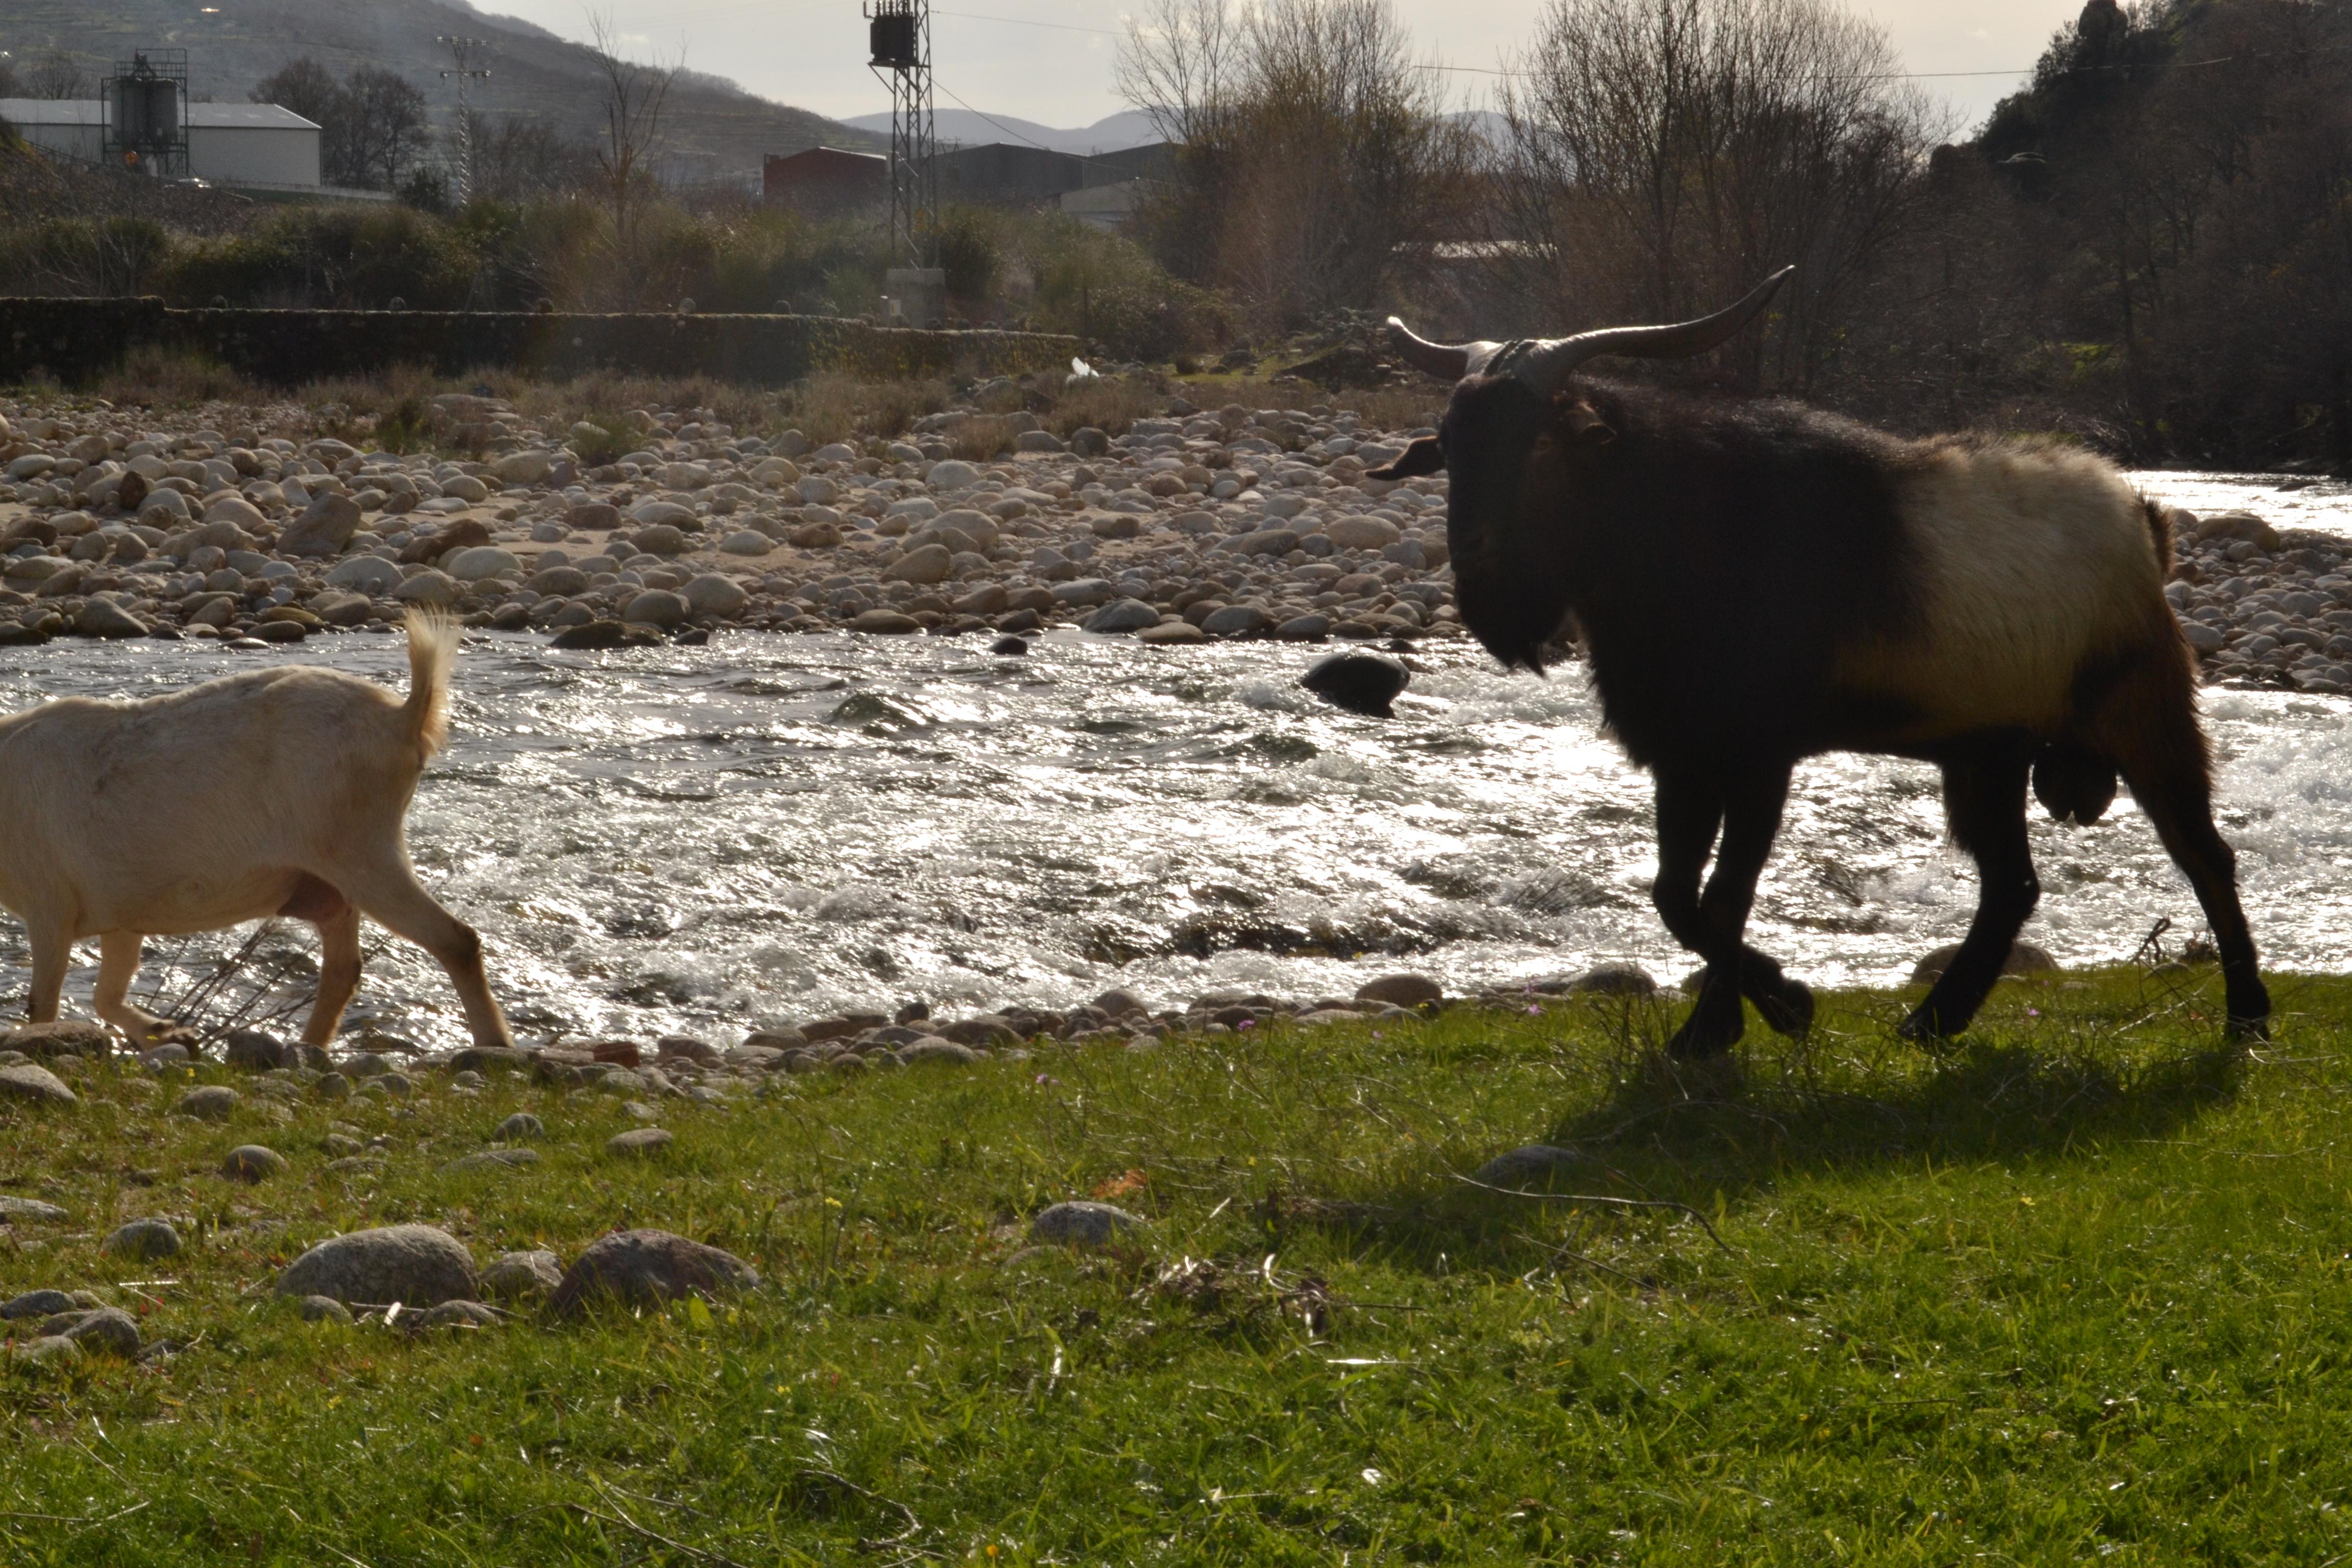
[1374,271,2270,1056]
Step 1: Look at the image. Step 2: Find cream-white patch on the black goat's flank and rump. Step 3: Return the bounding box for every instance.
[1839,442,2178,743]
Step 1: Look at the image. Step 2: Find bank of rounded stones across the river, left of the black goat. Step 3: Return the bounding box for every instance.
[0,395,1461,647]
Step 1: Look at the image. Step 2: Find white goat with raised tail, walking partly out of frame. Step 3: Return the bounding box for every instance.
[0,614,513,1046]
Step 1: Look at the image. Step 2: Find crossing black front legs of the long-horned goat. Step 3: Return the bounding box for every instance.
[1651,769,1814,1058]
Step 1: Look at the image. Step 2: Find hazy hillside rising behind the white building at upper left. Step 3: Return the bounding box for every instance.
[0,0,889,174]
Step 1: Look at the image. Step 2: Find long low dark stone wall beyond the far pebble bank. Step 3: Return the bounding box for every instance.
[0,299,1080,385]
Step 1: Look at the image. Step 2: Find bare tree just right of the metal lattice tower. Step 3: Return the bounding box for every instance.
[1117,0,1475,327]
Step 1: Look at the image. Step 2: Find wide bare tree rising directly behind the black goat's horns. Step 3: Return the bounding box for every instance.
[1498,0,1943,390]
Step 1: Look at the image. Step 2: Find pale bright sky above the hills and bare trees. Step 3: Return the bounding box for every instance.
[475,0,2081,129]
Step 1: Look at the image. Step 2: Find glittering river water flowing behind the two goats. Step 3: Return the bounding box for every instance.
[0,475,2352,1046]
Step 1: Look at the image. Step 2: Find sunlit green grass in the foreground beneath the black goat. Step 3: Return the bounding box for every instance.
[0,971,2352,1568]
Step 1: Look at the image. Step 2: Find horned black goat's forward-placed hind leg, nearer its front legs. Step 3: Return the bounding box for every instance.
[1903,750,2042,1039]
